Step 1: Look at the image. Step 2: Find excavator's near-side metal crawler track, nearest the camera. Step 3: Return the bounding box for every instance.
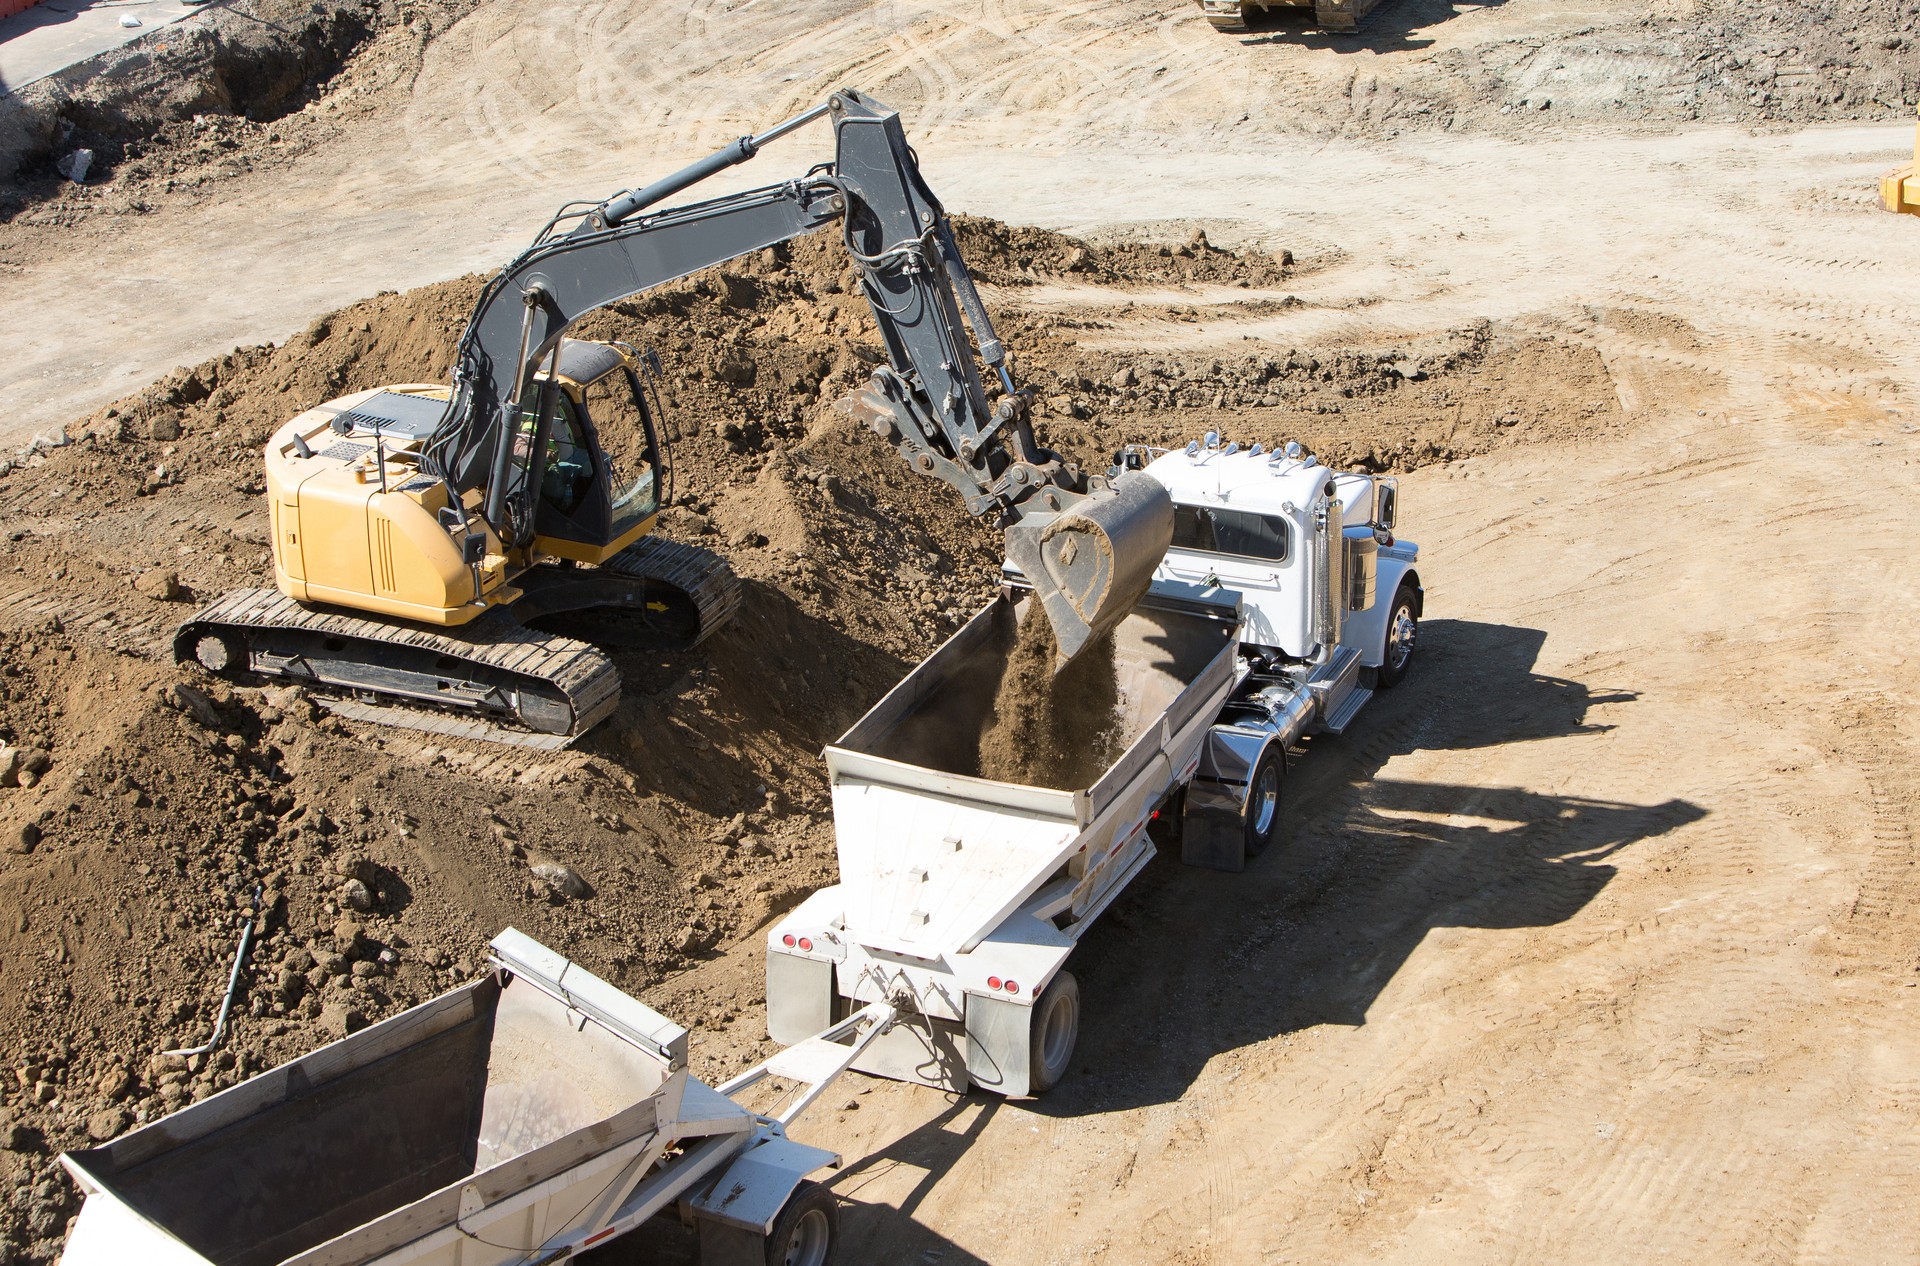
[173,590,620,747]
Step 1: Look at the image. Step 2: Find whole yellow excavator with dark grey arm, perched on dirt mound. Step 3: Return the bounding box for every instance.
[175,90,1173,747]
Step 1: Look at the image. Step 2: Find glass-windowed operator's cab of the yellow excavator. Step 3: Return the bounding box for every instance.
[515,338,664,563]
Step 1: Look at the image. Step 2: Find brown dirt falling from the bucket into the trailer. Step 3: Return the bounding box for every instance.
[979,601,1123,791]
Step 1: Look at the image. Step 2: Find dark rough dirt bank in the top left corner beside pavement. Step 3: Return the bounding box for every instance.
[0,0,478,214]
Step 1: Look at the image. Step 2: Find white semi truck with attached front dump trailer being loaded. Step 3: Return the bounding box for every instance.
[766,434,1423,1095]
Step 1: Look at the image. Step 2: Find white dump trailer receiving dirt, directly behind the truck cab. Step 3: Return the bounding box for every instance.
[768,590,1242,1095]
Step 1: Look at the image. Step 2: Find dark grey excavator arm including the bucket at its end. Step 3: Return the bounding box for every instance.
[422,92,1173,663]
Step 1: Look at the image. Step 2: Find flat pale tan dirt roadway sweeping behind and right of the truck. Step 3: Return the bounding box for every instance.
[0,0,1920,1266]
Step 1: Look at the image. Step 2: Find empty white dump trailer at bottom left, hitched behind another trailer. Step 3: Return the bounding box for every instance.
[61,930,881,1266]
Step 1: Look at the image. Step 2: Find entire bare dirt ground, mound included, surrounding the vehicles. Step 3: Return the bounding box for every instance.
[0,0,1920,1262]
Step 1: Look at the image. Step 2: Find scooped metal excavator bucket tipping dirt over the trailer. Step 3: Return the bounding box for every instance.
[1006,471,1173,670]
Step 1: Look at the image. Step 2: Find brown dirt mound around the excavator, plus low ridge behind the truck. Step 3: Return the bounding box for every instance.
[0,221,1611,1262]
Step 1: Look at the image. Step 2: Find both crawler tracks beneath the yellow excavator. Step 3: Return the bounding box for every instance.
[173,536,741,751]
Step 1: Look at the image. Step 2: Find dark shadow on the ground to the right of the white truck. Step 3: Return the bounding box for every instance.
[1035,621,1707,1116]
